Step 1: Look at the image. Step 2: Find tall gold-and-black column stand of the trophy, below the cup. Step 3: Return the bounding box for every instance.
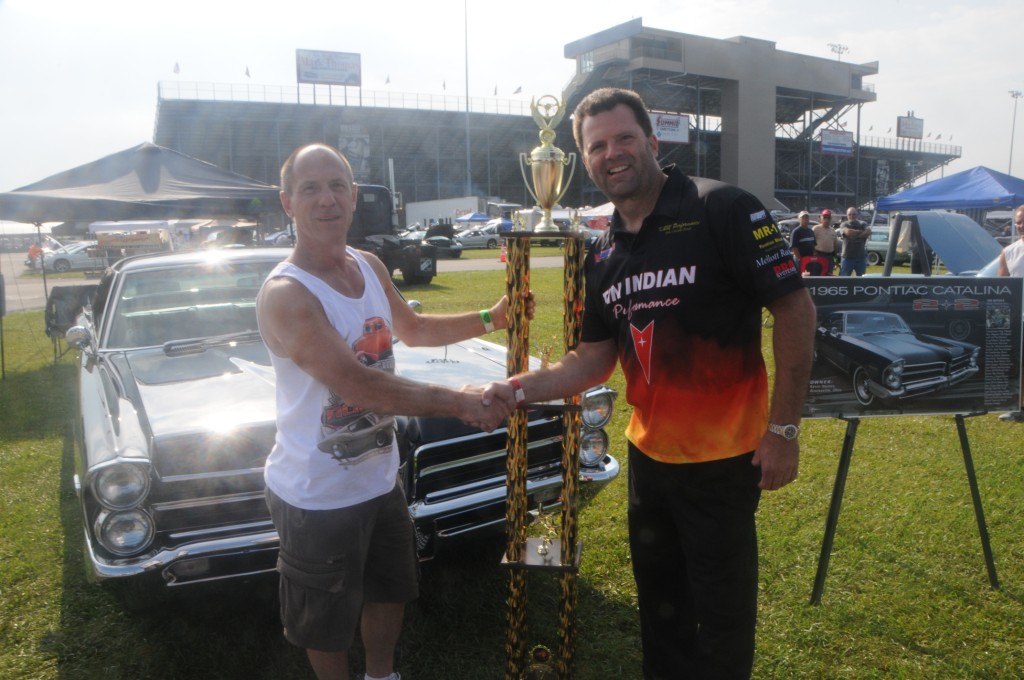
[502,230,586,680]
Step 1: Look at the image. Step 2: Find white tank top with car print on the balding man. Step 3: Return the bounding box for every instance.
[263,248,398,510]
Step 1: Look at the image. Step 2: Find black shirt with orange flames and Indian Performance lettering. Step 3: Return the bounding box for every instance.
[583,166,803,463]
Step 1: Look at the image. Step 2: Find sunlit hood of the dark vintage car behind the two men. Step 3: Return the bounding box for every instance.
[117,339,524,438]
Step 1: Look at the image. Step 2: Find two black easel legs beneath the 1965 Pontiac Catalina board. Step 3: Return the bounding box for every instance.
[811,414,999,604]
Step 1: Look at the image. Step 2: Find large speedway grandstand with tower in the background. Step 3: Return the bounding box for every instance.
[154,18,961,224]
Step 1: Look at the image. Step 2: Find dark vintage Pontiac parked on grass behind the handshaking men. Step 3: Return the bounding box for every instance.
[68,248,620,605]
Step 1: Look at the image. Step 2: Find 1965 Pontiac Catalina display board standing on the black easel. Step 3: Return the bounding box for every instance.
[803,277,1024,418]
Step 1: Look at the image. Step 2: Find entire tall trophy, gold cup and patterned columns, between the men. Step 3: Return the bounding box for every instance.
[502,95,586,680]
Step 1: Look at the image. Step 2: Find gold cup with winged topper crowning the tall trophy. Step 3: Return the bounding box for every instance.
[519,94,575,233]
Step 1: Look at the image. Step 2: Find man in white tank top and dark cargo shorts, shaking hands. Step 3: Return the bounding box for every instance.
[258,144,532,680]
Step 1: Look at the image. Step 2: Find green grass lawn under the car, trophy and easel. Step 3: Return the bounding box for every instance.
[0,266,1024,680]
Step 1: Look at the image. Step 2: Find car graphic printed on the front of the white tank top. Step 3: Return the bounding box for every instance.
[317,316,394,465]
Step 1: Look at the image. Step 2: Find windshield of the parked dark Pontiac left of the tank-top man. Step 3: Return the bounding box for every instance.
[105,262,274,348]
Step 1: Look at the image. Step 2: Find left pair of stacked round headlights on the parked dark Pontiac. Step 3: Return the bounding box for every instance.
[91,458,156,556]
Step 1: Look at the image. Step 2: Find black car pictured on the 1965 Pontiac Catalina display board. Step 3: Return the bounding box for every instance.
[814,310,981,407]
